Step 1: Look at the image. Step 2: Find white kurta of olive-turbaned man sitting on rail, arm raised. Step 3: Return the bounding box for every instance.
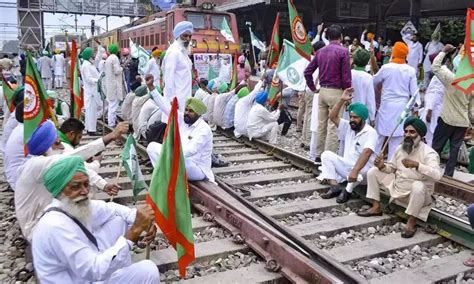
[149,90,214,182]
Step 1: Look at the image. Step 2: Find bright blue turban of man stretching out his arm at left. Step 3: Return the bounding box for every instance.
[27,120,58,156]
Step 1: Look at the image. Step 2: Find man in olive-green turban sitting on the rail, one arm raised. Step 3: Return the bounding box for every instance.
[146,75,214,182]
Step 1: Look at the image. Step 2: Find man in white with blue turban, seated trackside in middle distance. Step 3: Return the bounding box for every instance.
[247,91,284,144]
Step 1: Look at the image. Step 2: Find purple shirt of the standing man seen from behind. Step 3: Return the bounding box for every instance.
[304,41,351,92]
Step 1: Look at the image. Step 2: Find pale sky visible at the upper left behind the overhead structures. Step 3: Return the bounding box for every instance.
[0,0,130,41]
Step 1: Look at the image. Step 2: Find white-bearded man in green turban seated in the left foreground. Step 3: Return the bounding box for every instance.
[32,156,160,283]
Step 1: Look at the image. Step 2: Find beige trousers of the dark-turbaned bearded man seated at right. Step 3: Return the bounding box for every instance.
[367,167,431,217]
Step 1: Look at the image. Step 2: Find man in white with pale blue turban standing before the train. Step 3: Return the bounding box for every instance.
[161,21,194,123]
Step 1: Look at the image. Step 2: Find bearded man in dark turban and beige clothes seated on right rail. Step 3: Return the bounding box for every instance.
[357,117,442,238]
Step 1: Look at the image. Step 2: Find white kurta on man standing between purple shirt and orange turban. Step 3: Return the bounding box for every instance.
[346,69,376,121]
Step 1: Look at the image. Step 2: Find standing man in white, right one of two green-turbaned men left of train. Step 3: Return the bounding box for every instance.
[104,43,123,127]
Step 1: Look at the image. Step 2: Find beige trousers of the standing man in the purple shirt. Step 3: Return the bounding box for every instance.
[316,88,343,157]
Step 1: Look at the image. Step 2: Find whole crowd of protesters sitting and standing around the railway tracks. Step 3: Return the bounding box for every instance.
[0,17,474,283]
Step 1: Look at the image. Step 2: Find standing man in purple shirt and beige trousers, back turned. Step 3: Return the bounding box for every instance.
[304,25,352,162]
